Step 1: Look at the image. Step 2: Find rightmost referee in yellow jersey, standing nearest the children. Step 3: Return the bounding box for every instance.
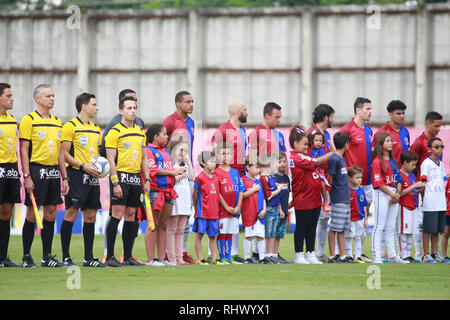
[105,96,150,267]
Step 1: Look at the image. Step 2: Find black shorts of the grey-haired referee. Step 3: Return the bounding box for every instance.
[25,163,63,206]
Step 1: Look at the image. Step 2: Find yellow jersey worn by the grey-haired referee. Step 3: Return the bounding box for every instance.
[19,111,62,166]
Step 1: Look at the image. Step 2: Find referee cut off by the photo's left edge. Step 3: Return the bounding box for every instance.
[0,83,21,267]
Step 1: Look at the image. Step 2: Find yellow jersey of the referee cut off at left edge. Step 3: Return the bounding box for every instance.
[0,112,17,163]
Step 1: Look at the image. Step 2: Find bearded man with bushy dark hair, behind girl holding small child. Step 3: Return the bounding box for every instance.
[306,104,335,263]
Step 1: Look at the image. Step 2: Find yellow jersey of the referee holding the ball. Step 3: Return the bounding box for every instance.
[62,117,102,170]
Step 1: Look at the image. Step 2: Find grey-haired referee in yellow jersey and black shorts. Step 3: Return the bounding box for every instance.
[19,84,69,267]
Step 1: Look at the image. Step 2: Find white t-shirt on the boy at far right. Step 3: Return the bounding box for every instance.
[420,158,447,211]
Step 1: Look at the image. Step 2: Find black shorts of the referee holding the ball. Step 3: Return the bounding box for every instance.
[65,167,102,210]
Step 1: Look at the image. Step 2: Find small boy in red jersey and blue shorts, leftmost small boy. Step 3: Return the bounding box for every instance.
[192,151,222,265]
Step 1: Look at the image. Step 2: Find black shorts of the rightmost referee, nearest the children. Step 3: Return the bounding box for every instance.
[109,171,144,208]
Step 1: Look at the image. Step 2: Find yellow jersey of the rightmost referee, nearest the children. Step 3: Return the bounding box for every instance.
[105,122,146,173]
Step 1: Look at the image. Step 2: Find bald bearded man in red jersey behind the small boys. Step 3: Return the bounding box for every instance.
[211,102,248,263]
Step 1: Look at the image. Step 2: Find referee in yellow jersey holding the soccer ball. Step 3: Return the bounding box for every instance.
[61,93,106,267]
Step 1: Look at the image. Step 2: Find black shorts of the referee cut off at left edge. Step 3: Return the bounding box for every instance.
[0,163,22,204]
